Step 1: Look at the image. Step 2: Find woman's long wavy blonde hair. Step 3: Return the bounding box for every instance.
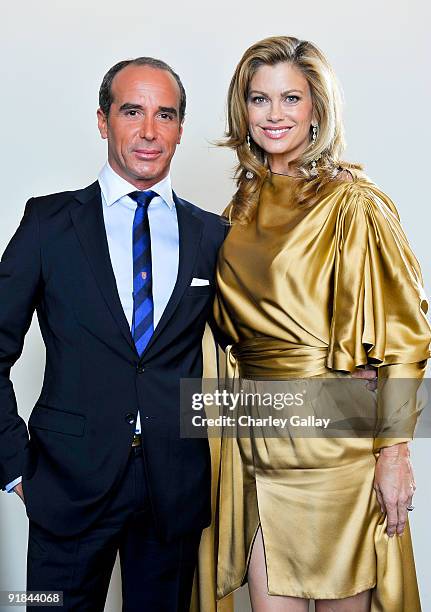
[220,36,361,223]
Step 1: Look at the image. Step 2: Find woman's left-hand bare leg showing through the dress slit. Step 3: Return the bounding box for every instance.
[248,528,308,612]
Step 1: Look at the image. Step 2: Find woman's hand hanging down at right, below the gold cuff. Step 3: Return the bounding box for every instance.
[374,442,416,537]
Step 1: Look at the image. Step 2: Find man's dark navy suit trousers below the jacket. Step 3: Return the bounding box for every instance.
[27,446,201,612]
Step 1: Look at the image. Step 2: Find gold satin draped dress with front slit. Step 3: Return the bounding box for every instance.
[214,173,431,612]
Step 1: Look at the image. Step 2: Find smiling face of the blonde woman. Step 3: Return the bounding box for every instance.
[247,62,314,174]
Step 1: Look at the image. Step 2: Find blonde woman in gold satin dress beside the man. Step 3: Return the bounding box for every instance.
[215,37,430,612]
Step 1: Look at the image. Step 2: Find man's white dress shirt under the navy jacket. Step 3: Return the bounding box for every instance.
[5,162,179,493]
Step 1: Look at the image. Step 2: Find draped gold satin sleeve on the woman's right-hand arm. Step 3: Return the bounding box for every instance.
[327,181,431,450]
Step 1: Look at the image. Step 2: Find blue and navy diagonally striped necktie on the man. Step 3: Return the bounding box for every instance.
[129,191,157,356]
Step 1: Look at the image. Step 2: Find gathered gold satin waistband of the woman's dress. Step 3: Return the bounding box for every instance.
[230,336,329,380]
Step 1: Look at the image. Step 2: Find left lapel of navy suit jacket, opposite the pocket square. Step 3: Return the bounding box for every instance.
[70,181,135,350]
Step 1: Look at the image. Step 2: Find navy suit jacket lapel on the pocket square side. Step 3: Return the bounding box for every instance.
[142,193,203,357]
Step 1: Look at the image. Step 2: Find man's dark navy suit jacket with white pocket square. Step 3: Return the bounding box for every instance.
[0,182,226,539]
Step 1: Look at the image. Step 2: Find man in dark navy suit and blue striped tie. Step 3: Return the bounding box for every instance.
[0,58,226,612]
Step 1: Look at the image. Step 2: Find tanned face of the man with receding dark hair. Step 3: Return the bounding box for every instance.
[97,65,183,189]
